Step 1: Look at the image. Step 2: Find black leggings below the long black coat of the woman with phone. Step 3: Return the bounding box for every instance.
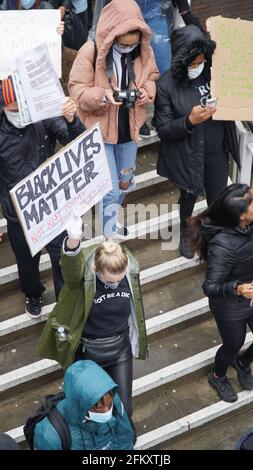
[178,154,228,228]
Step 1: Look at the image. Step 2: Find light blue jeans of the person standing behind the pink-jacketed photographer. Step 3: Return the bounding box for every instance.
[136,0,171,75]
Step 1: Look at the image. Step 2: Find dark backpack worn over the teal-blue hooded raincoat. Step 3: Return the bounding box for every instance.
[24,392,71,450]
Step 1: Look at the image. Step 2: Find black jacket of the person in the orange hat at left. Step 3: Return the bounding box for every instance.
[0,112,85,222]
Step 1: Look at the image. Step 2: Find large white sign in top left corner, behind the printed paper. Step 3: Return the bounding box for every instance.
[0,9,61,80]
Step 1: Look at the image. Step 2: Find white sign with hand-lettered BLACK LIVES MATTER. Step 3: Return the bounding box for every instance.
[10,124,112,256]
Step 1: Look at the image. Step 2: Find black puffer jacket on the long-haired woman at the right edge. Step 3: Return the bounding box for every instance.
[202,220,253,320]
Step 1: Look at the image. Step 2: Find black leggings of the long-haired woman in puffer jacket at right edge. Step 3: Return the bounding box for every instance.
[215,316,253,377]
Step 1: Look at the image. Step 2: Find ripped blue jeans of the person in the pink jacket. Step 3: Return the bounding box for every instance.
[100,142,137,236]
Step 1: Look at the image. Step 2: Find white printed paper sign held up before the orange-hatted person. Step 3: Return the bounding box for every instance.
[16,44,65,122]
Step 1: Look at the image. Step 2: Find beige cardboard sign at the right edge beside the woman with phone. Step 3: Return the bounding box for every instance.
[207,16,253,121]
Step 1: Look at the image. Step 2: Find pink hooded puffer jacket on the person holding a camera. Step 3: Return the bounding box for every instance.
[68,0,159,144]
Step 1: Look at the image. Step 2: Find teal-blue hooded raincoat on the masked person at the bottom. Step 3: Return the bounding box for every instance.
[34,360,133,450]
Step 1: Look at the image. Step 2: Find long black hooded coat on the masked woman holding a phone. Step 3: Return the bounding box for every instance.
[155,25,240,194]
